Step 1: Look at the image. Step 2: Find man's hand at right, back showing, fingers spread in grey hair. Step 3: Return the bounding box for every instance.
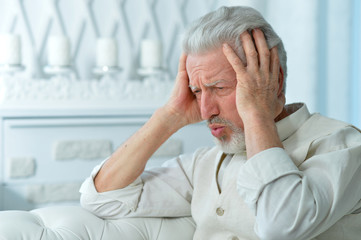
[223,29,285,122]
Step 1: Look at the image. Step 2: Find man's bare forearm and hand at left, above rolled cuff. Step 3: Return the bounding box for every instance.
[94,54,200,192]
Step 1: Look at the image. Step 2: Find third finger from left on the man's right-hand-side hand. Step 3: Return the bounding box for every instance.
[252,29,271,73]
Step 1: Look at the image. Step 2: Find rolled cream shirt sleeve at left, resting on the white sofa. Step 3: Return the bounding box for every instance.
[80,148,205,219]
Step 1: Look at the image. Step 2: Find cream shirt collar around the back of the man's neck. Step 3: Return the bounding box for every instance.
[276,103,311,142]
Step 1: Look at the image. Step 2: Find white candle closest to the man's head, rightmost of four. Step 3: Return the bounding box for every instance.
[140,39,163,68]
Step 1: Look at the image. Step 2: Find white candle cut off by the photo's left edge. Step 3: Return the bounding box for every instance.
[0,34,21,65]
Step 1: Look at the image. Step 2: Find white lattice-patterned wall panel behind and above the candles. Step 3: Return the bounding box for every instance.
[0,0,217,79]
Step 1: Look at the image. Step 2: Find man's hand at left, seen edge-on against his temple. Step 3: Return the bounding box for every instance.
[164,53,202,128]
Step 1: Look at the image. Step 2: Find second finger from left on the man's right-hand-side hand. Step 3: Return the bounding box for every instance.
[240,31,259,72]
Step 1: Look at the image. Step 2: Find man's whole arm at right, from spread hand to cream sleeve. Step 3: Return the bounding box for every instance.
[224,30,361,239]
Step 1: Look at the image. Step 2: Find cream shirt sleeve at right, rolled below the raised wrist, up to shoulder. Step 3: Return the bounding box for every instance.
[237,128,361,239]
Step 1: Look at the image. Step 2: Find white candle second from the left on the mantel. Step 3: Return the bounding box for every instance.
[48,36,71,66]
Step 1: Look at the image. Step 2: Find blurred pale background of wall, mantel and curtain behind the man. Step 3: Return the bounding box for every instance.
[0,0,361,209]
